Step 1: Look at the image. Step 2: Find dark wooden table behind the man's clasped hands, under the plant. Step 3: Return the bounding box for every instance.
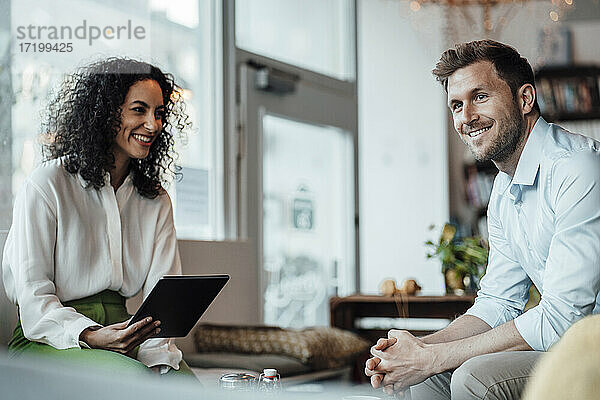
[329,295,475,342]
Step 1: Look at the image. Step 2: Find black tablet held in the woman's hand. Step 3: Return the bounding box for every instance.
[128,274,229,338]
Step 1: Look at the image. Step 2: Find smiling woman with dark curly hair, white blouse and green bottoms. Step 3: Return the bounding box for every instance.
[2,58,193,375]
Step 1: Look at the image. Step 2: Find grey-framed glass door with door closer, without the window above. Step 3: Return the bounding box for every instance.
[239,62,358,327]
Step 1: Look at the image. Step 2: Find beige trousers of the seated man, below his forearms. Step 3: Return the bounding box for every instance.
[410,351,544,400]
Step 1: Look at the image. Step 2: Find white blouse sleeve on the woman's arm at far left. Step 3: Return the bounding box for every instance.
[3,181,98,349]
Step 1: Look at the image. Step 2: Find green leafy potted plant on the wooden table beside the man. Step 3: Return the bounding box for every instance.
[425,224,488,294]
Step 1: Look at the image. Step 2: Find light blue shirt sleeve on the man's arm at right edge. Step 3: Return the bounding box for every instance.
[515,152,600,351]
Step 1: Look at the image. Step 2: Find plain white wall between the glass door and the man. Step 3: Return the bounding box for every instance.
[357,0,448,293]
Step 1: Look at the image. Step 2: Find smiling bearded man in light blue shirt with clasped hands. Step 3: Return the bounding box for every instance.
[365,40,600,400]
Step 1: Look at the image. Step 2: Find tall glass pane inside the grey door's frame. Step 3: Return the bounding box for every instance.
[261,114,354,327]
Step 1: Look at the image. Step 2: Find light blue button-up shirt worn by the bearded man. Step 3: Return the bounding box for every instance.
[467,118,600,351]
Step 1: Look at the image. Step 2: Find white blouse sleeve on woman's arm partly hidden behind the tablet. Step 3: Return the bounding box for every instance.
[137,193,183,370]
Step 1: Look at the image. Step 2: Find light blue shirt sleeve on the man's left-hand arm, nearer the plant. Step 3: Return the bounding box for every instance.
[466,203,531,328]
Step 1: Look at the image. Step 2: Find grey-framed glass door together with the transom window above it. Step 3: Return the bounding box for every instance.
[223,0,359,327]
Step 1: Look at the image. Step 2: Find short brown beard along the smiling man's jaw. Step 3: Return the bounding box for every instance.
[469,102,525,162]
